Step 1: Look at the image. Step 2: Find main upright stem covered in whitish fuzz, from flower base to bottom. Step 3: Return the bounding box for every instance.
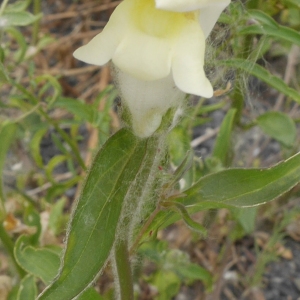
[112,134,165,300]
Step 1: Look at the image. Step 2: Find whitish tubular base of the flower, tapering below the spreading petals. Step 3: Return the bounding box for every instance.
[114,68,185,138]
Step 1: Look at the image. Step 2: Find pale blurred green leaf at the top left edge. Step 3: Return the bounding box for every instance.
[0,11,42,28]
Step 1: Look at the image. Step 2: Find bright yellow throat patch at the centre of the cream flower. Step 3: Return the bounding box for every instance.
[132,0,199,38]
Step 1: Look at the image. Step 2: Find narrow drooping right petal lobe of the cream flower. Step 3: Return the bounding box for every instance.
[172,22,213,98]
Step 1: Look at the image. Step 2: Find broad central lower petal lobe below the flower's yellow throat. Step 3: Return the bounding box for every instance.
[112,27,172,81]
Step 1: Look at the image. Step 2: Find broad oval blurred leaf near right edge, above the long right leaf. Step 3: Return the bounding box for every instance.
[257,111,297,148]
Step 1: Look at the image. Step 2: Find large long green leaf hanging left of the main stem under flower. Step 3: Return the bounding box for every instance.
[39,129,157,300]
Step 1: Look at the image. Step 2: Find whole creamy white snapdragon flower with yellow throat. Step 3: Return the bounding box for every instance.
[74,0,230,137]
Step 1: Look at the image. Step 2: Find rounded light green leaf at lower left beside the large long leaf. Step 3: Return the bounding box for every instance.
[14,235,60,284]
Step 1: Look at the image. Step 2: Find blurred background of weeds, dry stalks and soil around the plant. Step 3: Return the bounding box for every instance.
[0,0,300,300]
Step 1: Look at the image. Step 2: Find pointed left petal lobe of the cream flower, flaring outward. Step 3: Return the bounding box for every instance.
[73,1,131,65]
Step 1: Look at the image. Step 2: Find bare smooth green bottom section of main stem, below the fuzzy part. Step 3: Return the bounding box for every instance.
[115,239,134,300]
